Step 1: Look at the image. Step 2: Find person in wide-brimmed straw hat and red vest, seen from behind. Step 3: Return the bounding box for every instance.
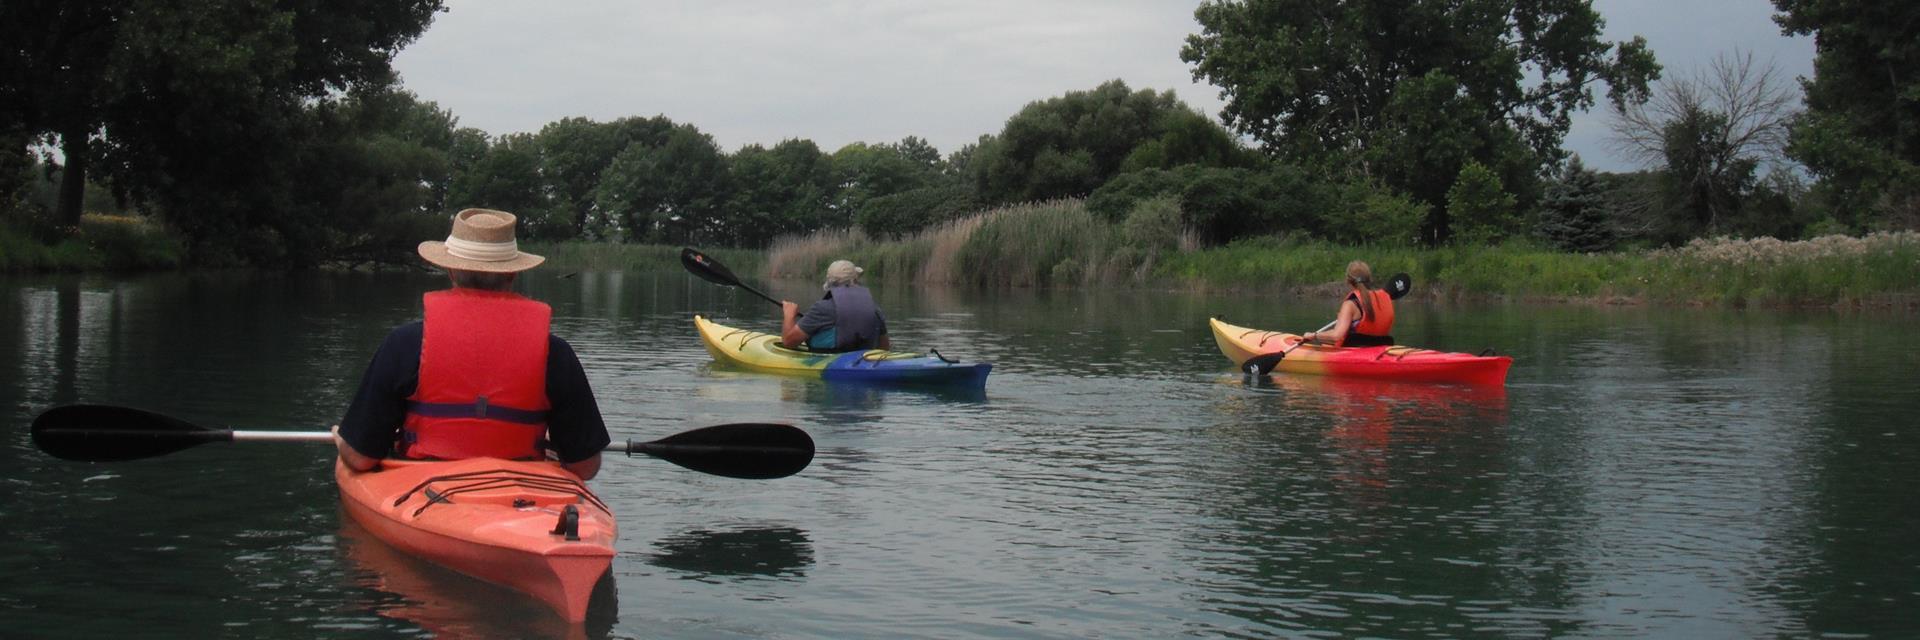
[334,209,612,479]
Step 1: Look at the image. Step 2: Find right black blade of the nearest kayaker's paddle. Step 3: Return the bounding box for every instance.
[626,423,814,480]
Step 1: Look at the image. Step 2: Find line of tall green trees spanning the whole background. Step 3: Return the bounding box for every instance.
[0,0,1920,267]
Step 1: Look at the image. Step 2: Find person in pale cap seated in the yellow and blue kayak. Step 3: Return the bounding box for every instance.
[780,259,893,352]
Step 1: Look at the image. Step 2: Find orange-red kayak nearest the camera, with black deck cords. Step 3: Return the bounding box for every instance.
[334,457,618,623]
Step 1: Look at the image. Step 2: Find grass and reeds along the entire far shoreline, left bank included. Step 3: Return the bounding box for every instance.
[0,200,1920,309]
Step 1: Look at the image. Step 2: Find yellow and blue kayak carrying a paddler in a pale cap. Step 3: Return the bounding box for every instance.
[693,315,993,386]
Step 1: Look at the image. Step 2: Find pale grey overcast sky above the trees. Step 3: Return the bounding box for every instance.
[394,0,1812,169]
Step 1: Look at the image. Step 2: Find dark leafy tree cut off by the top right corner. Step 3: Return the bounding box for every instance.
[1774,0,1920,229]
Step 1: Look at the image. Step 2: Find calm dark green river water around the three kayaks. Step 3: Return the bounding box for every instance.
[0,271,1920,638]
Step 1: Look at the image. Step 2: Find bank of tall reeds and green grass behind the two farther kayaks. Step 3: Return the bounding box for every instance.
[766,200,1920,308]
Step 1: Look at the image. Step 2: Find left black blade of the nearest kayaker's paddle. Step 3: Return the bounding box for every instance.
[33,404,234,461]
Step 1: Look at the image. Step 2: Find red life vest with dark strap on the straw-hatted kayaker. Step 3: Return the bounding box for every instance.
[401,288,553,459]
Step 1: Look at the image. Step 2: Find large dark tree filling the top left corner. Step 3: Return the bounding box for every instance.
[0,0,442,249]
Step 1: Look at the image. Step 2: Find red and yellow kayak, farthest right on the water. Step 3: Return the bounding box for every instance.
[1208,319,1513,384]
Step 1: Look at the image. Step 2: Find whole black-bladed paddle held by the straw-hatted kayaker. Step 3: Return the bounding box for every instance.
[31,404,814,480]
